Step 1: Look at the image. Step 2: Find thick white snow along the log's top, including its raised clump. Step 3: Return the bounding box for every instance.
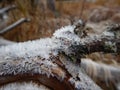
[0,26,80,61]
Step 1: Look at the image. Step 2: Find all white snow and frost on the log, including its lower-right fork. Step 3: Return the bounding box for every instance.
[0,23,103,90]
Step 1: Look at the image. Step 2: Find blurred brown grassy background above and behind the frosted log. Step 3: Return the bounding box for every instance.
[0,0,120,42]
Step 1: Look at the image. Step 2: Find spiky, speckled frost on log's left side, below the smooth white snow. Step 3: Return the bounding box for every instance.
[0,58,58,77]
